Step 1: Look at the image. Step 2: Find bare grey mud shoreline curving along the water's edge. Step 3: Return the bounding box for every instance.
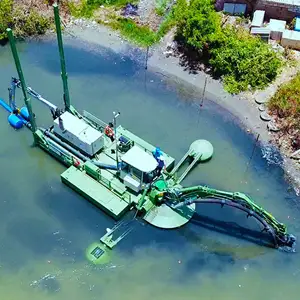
[47,20,300,196]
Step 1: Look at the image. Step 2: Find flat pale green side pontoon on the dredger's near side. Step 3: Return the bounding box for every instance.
[61,166,130,220]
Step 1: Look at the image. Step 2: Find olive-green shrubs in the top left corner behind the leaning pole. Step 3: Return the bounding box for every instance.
[0,0,50,41]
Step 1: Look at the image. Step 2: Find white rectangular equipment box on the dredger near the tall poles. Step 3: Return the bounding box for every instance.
[54,112,104,156]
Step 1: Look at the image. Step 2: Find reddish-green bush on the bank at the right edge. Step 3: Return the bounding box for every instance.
[268,73,300,131]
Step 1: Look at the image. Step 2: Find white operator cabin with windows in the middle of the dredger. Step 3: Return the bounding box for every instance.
[120,146,158,193]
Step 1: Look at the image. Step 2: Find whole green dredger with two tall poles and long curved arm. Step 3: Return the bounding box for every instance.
[0,4,296,263]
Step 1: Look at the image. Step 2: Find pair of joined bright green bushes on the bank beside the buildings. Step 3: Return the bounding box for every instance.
[177,0,282,93]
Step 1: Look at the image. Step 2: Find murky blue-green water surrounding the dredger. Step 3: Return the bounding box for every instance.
[0,40,300,300]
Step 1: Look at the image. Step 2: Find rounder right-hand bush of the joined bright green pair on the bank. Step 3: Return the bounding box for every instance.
[209,27,282,93]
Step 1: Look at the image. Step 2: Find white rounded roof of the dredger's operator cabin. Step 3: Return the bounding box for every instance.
[121,146,157,173]
